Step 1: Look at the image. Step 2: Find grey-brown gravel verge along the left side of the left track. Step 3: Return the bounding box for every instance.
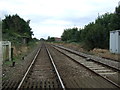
[2,42,38,82]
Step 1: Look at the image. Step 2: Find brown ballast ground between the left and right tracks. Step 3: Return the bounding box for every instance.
[49,44,117,88]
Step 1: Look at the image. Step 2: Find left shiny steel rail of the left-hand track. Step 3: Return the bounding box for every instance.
[16,47,41,90]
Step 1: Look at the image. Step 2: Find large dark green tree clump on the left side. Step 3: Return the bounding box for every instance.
[2,14,33,43]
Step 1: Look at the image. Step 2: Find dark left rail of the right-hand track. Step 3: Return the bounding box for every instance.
[53,46,120,88]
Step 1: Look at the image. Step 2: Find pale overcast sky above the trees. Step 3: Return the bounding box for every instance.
[0,0,119,39]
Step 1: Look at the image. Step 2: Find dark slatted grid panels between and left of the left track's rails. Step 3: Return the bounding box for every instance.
[2,80,61,90]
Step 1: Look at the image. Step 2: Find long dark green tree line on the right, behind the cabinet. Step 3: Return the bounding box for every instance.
[61,6,120,50]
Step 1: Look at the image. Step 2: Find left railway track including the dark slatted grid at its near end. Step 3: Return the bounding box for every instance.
[2,44,65,90]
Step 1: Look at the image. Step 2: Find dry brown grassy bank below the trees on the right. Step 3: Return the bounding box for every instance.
[53,43,120,60]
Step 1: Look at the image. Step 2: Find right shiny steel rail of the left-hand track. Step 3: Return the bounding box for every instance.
[46,47,66,90]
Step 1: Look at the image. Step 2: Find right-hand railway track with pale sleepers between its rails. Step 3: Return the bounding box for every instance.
[53,45,120,88]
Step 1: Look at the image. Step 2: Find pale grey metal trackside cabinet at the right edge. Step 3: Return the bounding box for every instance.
[110,30,120,54]
